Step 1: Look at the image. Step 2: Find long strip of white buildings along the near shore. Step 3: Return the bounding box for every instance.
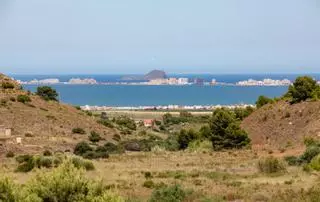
[81,104,255,111]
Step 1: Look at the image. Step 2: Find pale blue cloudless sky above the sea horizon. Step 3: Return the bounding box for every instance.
[0,0,320,74]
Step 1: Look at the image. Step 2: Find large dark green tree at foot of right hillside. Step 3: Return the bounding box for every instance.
[210,109,250,150]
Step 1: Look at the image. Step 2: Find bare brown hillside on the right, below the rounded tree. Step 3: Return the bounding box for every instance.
[242,101,320,148]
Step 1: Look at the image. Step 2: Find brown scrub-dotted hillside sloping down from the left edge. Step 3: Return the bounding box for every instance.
[0,74,116,156]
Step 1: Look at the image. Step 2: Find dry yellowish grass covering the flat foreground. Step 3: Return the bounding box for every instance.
[1,150,317,201]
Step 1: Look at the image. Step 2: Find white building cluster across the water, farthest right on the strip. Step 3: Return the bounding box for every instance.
[236,79,292,86]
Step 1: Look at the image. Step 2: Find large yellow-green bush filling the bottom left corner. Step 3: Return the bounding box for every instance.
[0,160,124,202]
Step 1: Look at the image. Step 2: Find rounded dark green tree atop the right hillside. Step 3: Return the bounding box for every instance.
[287,76,318,103]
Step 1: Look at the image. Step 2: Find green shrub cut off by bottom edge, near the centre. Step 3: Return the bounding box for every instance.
[149,185,187,202]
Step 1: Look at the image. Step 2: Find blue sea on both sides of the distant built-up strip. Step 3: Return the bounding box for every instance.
[10,74,320,107]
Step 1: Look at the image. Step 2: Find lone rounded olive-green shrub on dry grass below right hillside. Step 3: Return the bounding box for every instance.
[258,156,286,174]
